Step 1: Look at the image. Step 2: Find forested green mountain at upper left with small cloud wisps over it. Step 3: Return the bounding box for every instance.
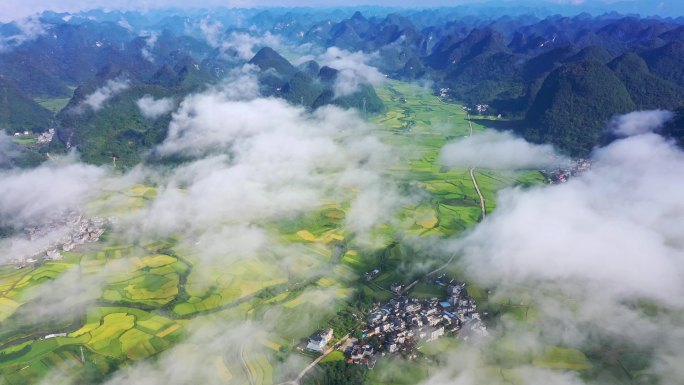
[57,57,216,167]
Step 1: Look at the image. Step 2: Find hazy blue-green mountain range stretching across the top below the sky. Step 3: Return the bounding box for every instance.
[0,8,684,165]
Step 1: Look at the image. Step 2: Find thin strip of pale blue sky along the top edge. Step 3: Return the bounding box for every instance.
[0,0,684,21]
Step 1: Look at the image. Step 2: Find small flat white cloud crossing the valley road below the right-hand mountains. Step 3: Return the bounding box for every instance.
[439,130,566,170]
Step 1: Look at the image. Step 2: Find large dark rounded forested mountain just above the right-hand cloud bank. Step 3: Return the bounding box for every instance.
[523,61,636,156]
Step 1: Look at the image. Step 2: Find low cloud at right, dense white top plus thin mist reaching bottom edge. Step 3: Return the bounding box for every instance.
[425,113,684,385]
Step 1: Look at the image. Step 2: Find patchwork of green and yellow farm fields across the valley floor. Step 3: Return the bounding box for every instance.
[0,81,552,384]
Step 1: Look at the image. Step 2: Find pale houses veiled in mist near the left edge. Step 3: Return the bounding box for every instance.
[15,212,109,269]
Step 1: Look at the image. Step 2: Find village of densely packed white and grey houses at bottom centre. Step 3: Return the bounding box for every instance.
[306,270,487,368]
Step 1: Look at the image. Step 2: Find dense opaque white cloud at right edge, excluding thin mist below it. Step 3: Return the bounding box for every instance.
[454,134,684,303]
